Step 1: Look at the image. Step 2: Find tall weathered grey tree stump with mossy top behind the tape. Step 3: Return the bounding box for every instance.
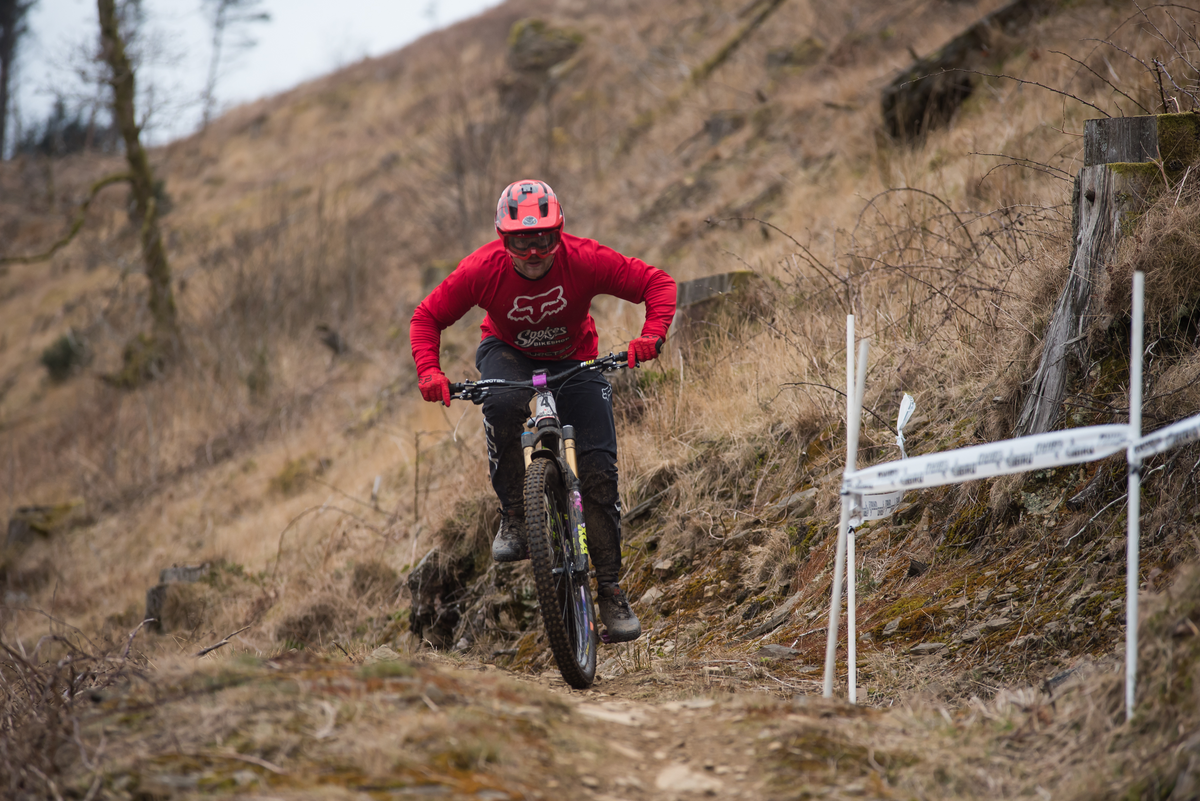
[1014,114,1200,436]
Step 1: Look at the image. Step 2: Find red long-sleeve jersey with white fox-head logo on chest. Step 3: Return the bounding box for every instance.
[409,227,676,374]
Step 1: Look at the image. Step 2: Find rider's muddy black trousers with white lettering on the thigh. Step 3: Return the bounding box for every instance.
[475,337,620,583]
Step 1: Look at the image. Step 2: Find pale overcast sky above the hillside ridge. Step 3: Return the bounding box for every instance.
[16,0,502,144]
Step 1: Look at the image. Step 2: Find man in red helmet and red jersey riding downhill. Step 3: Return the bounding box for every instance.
[409,180,676,643]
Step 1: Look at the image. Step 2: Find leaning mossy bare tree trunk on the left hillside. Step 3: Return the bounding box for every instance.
[96,0,179,354]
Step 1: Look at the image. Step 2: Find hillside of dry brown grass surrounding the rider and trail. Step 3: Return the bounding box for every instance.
[7,0,1200,797]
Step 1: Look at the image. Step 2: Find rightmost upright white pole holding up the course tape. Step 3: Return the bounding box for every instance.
[1126,272,1146,721]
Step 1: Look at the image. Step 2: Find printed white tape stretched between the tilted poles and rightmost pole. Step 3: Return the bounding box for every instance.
[842,426,1128,495]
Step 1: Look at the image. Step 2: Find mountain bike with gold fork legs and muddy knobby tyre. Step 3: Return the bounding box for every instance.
[450,353,628,689]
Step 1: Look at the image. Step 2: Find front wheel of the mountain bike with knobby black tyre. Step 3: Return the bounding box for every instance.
[524,459,596,689]
